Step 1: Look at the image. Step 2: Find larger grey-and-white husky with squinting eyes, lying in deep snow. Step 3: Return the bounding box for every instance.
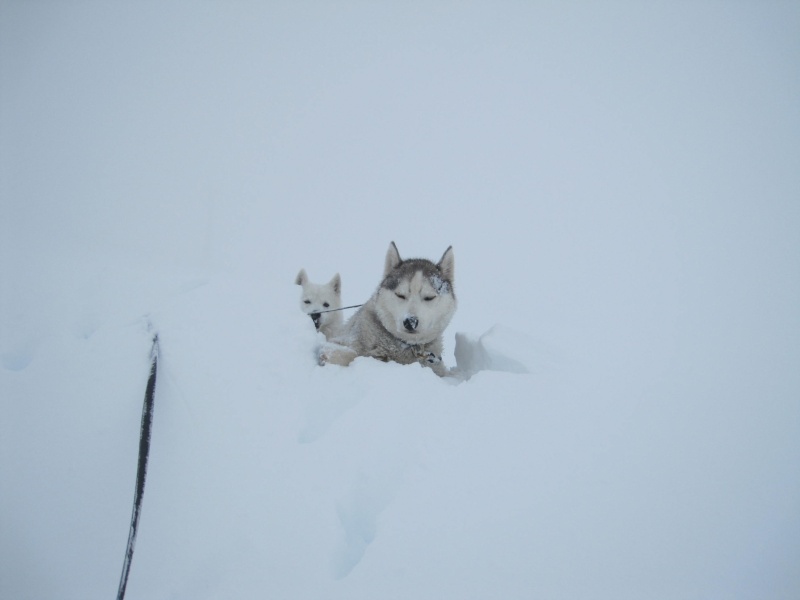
[319,242,456,377]
